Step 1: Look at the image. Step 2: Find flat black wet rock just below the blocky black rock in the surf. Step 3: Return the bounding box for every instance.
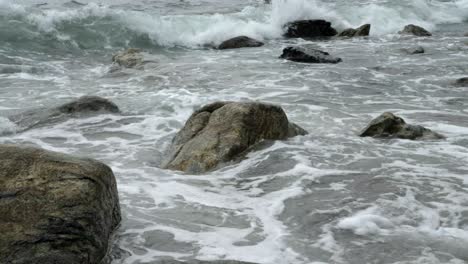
[280,47,342,63]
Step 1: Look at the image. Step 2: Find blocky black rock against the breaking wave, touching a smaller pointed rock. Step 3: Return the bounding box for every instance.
[284,20,338,38]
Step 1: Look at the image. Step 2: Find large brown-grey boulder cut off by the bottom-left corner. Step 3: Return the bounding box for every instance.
[0,145,120,264]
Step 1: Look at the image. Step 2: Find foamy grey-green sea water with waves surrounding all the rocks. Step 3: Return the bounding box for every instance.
[0,0,468,264]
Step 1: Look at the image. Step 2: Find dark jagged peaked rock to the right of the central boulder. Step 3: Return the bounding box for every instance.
[359,112,444,140]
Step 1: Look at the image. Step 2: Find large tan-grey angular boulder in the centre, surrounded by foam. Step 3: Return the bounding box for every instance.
[164,102,307,173]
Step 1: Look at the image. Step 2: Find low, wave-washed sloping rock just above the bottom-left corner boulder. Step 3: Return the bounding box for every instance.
[9,96,120,132]
